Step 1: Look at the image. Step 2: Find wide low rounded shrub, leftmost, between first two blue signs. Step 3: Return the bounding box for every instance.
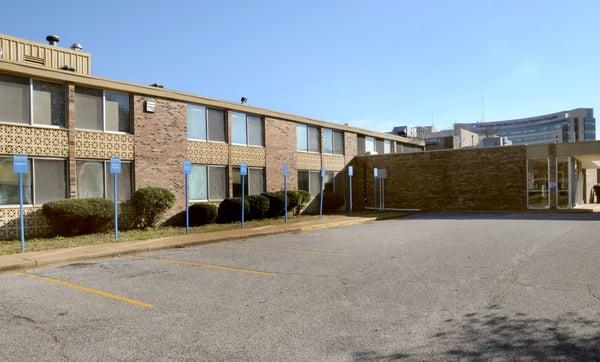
[42,198,114,236]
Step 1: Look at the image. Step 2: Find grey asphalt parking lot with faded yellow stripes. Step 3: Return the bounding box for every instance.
[0,214,600,361]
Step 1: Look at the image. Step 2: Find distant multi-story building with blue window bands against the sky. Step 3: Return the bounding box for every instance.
[455,108,596,144]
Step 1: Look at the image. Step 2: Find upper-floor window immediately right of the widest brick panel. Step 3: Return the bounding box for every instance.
[187,104,225,142]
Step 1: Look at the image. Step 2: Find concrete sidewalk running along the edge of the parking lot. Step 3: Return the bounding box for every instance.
[0,212,409,272]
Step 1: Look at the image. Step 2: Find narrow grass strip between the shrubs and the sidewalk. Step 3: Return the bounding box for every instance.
[0,215,327,255]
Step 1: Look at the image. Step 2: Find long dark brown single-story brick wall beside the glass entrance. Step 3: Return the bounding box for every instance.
[352,146,527,211]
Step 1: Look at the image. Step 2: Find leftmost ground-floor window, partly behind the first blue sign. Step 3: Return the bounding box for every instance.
[0,157,67,205]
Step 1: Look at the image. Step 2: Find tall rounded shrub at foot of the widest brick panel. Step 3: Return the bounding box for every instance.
[129,187,175,228]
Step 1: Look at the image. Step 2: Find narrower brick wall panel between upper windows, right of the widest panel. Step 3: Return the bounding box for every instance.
[265,118,298,191]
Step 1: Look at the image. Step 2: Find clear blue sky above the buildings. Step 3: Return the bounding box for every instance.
[5,0,600,131]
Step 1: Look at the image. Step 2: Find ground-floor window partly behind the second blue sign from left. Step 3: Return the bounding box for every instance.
[77,160,133,201]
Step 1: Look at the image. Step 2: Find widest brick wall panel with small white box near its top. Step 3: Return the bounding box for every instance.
[133,95,188,216]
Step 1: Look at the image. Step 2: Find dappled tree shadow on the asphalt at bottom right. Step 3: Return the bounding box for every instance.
[354,306,600,361]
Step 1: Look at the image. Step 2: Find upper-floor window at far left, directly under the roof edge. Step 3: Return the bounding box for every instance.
[0,74,65,127]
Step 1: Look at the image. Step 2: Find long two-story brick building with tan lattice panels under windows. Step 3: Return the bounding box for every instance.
[0,34,424,238]
